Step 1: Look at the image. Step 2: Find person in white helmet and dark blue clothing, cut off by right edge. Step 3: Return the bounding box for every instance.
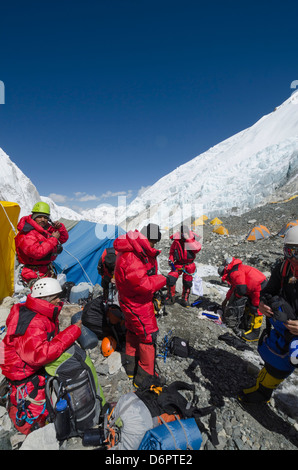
[238,226,298,404]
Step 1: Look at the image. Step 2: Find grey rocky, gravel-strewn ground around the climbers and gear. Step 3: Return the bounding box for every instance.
[0,198,298,450]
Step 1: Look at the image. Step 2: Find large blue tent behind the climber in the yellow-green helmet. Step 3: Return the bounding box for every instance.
[53,220,125,285]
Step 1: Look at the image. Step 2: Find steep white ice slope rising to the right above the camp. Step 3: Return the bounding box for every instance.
[122,97,298,226]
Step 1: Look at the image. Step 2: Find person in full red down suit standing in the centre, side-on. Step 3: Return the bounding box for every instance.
[114,224,166,387]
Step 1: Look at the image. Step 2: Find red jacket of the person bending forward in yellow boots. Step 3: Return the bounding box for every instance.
[222,258,266,307]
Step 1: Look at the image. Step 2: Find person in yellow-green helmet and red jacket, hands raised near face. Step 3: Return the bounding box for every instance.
[15,202,68,287]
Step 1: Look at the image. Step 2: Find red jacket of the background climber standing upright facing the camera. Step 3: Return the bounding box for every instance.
[169,231,202,265]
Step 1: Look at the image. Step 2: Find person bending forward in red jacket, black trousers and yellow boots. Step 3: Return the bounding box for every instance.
[218,257,267,341]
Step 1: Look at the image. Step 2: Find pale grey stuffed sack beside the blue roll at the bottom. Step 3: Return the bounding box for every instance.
[104,392,153,450]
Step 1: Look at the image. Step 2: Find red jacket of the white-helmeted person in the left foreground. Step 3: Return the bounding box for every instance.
[0,295,81,380]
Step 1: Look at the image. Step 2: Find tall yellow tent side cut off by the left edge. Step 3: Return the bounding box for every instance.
[0,201,20,302]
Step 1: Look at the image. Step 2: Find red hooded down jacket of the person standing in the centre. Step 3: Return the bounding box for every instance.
[114,230,166,340]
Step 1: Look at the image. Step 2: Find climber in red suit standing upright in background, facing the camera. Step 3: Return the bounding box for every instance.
[167,225,202,307]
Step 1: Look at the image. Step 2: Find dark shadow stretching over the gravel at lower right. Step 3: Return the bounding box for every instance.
[185,347,298,447]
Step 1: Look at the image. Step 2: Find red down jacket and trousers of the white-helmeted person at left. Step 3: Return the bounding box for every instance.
[0,295,81,434]
